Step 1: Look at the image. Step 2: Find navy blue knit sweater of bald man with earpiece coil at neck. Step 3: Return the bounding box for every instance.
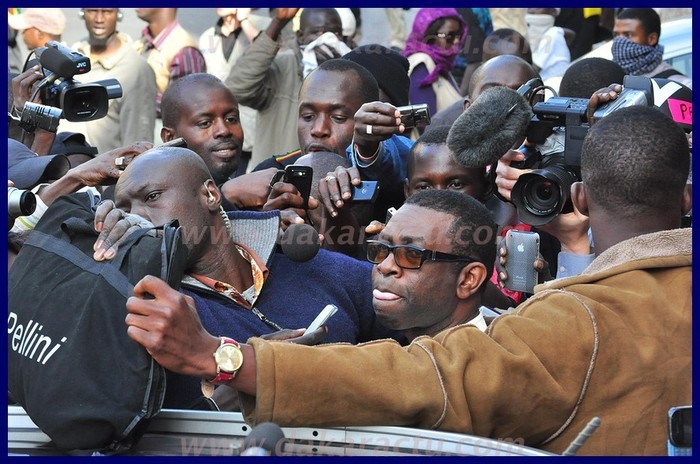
[163,250,395,408]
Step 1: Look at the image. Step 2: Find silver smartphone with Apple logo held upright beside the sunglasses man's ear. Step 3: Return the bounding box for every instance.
[504,229,540,293]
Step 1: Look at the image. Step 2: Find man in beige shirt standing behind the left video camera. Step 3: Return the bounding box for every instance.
[61,8,157,153]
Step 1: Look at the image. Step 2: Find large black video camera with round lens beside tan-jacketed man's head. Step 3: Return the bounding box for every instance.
[511,75,692,226]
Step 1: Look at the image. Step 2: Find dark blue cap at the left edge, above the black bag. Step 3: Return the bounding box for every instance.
[7,138,70,189]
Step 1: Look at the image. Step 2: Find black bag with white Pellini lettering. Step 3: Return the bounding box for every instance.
[7,193,186,454]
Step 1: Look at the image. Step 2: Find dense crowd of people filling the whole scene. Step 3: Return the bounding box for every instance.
[8,8,692,455]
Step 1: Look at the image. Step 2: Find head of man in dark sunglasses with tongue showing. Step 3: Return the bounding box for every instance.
[367,190,496,340]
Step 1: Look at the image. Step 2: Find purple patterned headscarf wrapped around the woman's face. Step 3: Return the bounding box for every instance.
[403,8,467,87]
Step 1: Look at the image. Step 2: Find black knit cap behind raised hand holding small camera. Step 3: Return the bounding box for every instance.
[343,44,411,106]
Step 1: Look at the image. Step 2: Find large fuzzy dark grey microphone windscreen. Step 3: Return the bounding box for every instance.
[447,87,532,168]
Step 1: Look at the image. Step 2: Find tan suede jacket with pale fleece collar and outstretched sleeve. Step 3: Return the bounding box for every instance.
[243,229,692,455]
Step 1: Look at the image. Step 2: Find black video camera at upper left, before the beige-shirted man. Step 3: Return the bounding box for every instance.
[32,41,122,121]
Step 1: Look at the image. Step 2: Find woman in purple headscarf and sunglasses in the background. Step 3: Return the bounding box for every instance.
[403,8,467,123]
